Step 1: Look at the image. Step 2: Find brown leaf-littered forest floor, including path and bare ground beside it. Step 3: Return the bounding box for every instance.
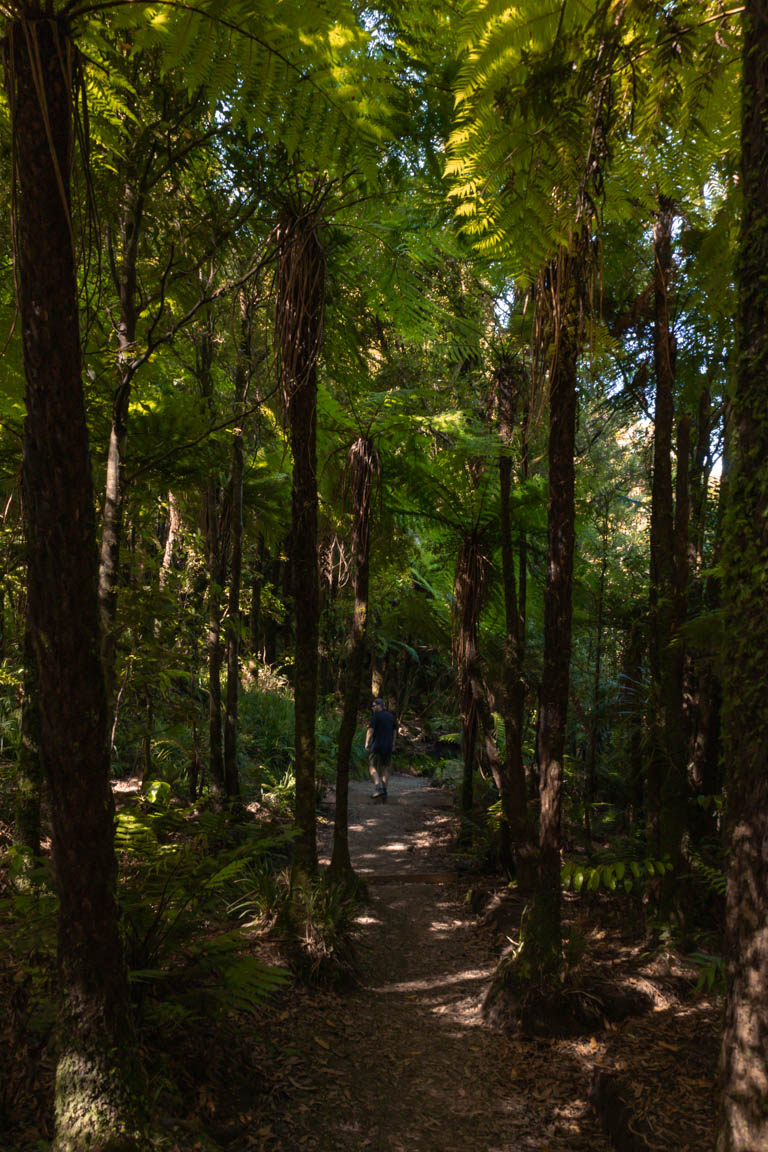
[0,775,722,1152]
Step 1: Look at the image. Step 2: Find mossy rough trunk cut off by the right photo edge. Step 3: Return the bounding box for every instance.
[717,0,768,1152]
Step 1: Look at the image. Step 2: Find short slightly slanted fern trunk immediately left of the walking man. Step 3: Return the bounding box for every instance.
[330,437,379,877]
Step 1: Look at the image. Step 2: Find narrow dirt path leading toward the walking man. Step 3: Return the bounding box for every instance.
[252,776,607,1152]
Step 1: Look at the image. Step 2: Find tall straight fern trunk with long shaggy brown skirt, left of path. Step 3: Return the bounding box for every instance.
[276,194,326,873]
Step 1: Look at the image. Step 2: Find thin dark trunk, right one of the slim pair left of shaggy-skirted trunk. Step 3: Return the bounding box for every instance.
[225,340,245,797]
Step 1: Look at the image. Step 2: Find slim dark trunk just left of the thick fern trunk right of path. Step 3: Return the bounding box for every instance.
[497,370,537,892]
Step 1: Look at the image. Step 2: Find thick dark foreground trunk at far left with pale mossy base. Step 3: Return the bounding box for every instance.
[5,9,139,1152]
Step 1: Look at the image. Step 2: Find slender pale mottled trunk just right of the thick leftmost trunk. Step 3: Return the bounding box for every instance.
[99,181,144,708]
